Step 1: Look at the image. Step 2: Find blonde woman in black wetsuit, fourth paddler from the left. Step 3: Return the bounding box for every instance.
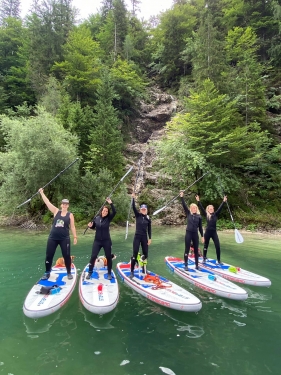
[180,191,204,271]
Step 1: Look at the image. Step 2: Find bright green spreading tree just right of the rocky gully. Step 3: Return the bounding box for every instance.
[155,80,270,197]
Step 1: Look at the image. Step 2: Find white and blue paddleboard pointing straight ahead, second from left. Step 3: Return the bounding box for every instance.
[79,265,119,314]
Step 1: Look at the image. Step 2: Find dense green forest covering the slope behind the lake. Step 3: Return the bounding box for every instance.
[0,0,281,229]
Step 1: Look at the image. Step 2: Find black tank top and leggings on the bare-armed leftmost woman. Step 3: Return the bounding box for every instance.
[45,211,71,273]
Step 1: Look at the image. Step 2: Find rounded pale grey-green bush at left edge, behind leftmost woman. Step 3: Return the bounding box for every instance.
[0,108,77,213]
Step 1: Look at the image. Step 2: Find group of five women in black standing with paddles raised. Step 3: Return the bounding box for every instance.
[39,188,227,280]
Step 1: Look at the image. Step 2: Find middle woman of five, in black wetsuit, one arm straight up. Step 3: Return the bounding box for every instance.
[130,193,151,278]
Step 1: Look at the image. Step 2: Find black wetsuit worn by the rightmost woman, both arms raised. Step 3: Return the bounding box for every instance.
[198,201,224,262]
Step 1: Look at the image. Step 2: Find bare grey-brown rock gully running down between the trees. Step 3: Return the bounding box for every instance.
[126,88,185,225]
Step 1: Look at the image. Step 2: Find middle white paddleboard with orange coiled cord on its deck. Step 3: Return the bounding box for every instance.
[117,263,202,312]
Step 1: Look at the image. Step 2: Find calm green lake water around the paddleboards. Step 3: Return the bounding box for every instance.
[0,228,281,375]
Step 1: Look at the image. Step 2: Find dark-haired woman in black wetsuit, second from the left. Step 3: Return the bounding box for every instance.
[86,198,116,280]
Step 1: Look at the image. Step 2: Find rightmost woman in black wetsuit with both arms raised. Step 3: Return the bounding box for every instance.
[195,195,227,264]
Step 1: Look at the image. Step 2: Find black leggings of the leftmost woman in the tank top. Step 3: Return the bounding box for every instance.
[45,238,71,273]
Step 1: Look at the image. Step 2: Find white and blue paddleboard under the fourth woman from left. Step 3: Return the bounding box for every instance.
[165,256,248,300]
